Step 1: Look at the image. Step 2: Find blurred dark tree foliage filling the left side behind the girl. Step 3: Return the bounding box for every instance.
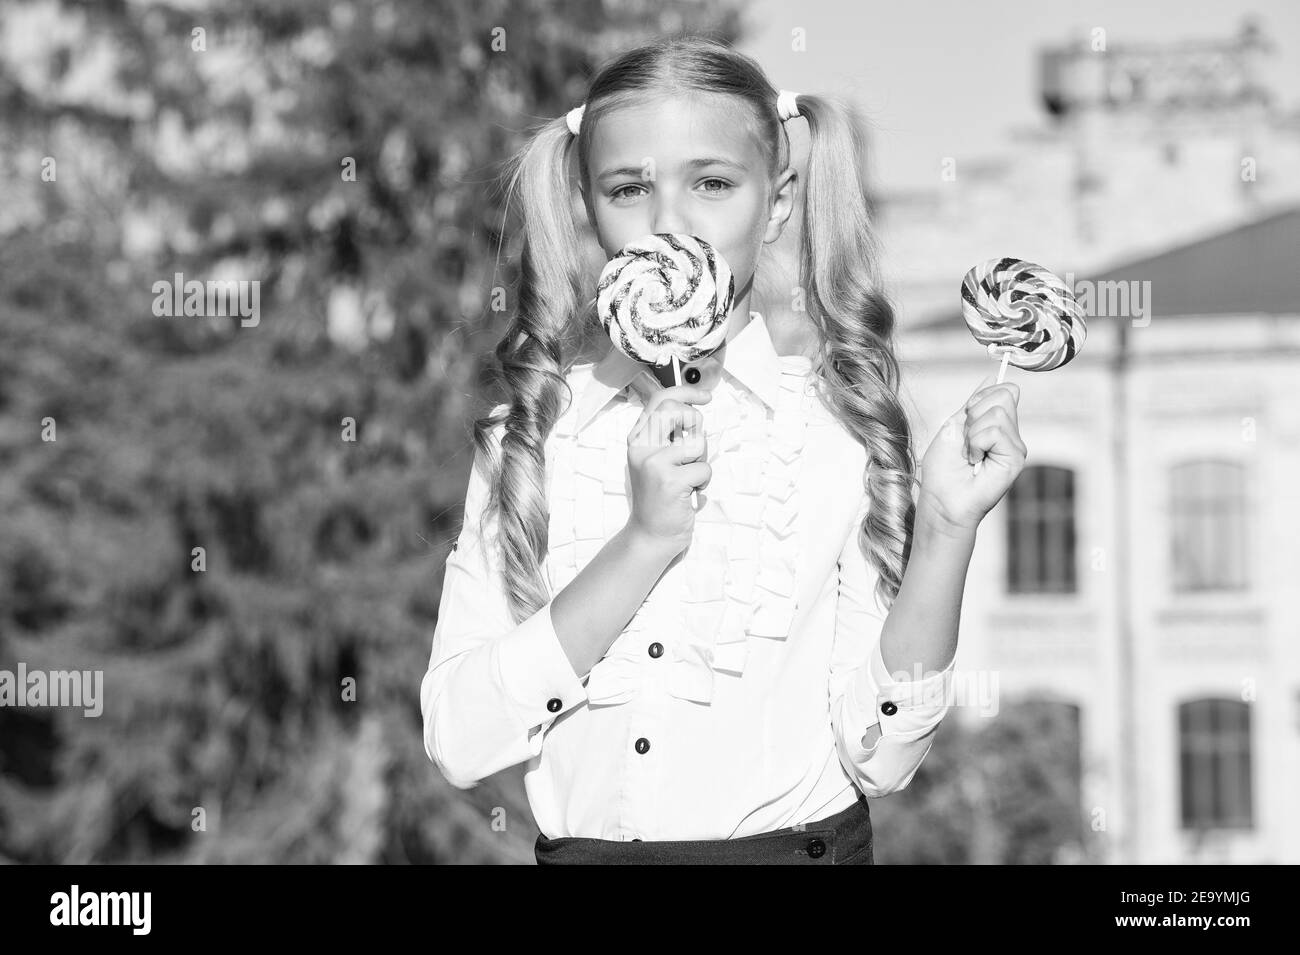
[0,0,736,863]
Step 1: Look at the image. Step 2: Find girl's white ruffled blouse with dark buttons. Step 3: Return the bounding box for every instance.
[420,312,956,841]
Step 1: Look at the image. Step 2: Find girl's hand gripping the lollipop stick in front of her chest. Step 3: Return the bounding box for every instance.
[628,385,714,556]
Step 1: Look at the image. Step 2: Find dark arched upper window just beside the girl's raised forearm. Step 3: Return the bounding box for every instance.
[1006,465,1075,594]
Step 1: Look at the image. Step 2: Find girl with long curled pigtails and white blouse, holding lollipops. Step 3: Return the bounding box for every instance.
[421,38,1026,864]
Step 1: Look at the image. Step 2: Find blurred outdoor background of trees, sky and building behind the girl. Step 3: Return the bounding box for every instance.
[0,0,1300,864]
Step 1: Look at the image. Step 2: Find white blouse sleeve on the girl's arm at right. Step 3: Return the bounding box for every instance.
[829,493,956,796]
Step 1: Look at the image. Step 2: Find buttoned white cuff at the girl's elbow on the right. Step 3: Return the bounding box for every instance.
[845,639,957,759]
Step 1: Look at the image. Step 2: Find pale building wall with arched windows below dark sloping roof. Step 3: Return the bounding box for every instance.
[900,204,1300,864]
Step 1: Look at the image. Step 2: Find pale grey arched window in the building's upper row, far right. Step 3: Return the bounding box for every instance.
[1169,461,1247,592]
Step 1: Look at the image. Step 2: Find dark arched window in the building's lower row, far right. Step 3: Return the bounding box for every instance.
[1178,699,1253,829]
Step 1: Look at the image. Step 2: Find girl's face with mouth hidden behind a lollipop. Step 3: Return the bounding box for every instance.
[581,94,796,320]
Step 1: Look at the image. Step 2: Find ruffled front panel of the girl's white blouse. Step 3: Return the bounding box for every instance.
[547,356,814,706]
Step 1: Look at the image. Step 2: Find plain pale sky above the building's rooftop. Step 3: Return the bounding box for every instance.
[738,0,1300,191]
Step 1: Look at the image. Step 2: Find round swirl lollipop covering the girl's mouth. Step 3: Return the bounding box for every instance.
[595,233,736,508]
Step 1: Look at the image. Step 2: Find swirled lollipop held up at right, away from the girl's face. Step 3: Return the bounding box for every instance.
[962,256,1088,474]
